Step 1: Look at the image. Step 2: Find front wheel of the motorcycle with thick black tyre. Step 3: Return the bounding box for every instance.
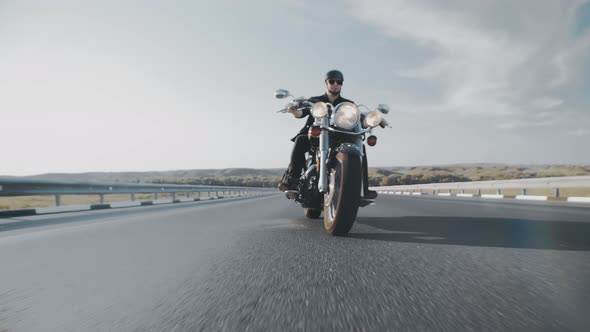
[324,153,362,236]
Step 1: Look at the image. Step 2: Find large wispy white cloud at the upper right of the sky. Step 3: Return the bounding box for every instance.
[350,0,590,122]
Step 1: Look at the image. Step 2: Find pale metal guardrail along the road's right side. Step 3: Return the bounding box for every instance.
[373,176,590,197]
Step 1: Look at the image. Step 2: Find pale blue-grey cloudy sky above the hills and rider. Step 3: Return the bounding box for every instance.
[0,0,590,175]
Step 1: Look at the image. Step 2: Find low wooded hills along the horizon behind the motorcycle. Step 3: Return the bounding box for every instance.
[2,164,590,187]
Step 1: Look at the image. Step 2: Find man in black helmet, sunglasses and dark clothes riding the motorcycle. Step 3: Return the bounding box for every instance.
[279,70,377,199]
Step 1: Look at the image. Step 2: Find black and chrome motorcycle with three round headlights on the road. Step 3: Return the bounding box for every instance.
[275,89,391,236]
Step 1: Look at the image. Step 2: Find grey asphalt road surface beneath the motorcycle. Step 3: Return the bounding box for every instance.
[0,195,590,331]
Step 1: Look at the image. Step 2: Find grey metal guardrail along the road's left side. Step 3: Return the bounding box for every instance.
[0,178,273,206]
